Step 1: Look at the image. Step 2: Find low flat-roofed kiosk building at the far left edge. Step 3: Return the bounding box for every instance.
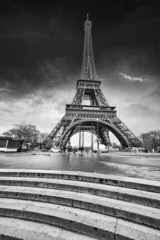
[0,135,24,152]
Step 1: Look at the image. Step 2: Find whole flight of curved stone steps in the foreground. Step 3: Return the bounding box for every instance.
[0,169,160,240]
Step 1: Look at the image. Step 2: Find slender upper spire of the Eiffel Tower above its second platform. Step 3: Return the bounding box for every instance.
[80,14,97,80]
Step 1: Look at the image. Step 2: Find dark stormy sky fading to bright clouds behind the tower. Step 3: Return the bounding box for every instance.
[0,0,160,139]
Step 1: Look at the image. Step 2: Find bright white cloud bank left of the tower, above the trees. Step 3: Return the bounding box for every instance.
[0,77,74,133]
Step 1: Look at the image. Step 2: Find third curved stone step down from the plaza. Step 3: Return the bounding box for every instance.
[0,186,160,229]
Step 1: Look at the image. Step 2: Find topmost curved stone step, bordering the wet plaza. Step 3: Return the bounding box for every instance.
[0,169,160,193]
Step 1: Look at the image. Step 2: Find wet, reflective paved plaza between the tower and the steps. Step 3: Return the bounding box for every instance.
[0,151,160,180]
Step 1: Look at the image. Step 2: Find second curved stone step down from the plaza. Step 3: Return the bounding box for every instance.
[0,177,160,208]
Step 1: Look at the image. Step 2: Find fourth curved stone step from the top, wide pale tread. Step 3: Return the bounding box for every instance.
[0,199,160,240]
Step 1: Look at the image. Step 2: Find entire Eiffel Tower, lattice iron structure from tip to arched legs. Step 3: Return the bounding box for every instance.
[43,14,141,148]
